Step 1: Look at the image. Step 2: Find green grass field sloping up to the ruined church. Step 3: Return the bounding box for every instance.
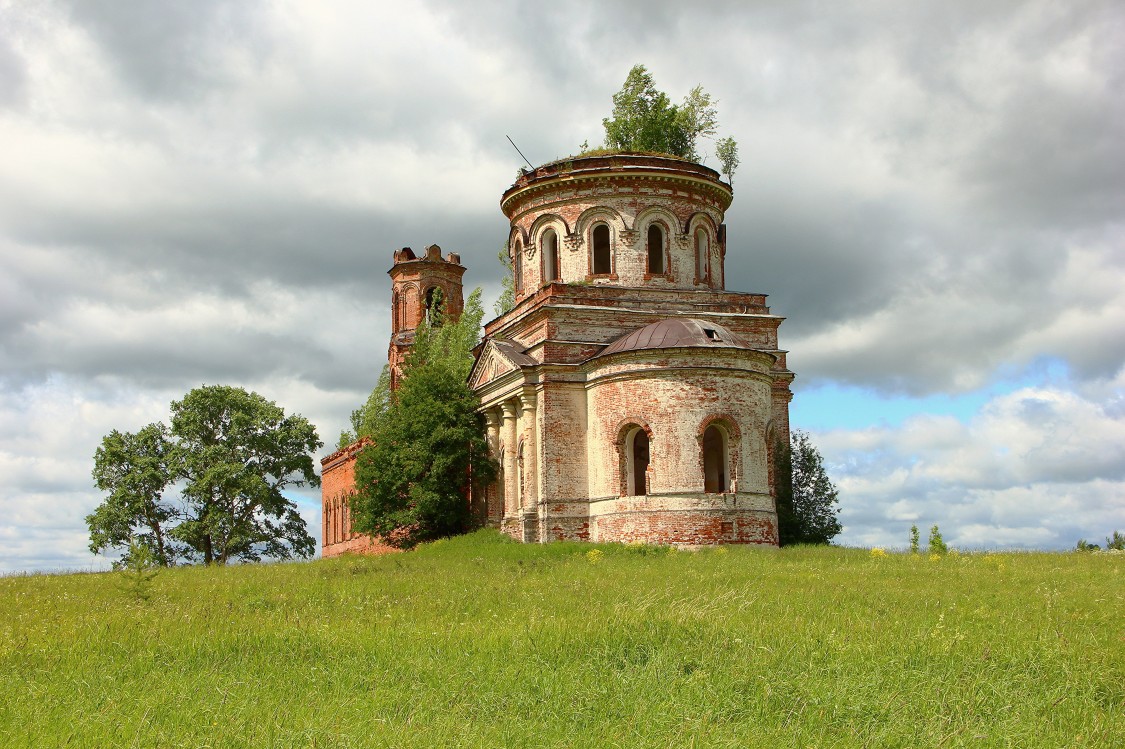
[0,532,1125,748]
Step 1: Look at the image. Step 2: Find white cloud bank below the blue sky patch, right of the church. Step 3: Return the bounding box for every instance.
[815,380,1125,548]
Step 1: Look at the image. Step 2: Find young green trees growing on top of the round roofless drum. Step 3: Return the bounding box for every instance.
[602,65,738,173]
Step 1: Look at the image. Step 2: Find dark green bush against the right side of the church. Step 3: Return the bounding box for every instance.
[774,430,843,547]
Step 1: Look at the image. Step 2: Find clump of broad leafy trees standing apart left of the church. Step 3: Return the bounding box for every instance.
[86,386,322,565]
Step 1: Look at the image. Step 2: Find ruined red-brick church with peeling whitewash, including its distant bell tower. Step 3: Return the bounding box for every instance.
[322,154,793,557]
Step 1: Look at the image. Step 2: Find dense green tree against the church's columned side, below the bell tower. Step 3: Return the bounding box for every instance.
[350,289,496,549]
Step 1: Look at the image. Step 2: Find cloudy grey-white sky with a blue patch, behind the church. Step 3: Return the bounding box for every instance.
[0,0,1125,571]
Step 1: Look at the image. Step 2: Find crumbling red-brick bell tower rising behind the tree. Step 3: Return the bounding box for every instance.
[387,244,465,390]
